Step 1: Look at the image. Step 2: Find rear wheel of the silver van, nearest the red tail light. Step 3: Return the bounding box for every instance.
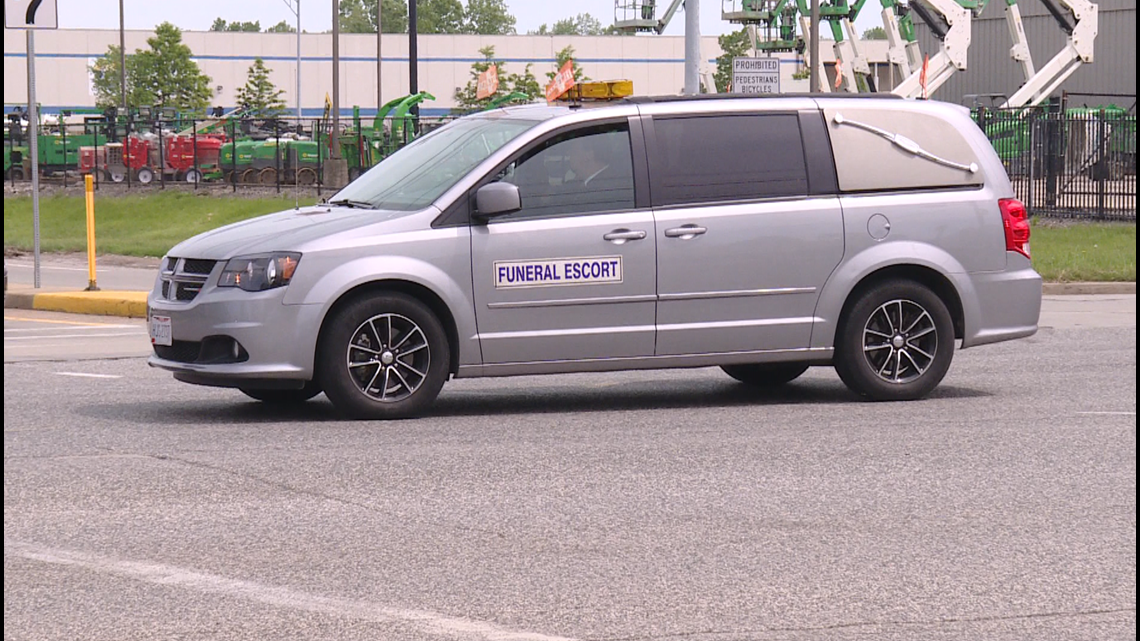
[834,281,954,400]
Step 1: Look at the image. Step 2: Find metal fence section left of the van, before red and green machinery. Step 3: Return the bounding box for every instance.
[5,115,450,195]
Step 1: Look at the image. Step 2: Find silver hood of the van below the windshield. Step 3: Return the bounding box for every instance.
[168,205,417,260]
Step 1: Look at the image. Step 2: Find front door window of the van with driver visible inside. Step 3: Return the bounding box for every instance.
[502,123,634,219]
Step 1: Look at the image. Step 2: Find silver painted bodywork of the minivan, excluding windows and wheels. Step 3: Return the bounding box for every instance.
[148,97,1041,386]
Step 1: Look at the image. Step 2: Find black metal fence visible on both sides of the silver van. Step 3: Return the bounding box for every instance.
[5,104,1137,221]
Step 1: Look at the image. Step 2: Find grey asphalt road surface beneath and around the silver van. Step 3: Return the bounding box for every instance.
[5,295,1137,641]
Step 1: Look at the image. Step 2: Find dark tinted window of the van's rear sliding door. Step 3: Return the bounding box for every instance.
[650,114,807,206]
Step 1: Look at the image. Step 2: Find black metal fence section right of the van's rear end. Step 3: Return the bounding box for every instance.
[975,99,1137,221]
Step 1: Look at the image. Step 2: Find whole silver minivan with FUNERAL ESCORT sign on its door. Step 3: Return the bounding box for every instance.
[148,95,1041,419]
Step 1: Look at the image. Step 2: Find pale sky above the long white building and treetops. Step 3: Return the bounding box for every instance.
[46,0,879,35]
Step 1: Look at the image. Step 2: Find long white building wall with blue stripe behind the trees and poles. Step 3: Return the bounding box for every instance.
[3,30,870,115]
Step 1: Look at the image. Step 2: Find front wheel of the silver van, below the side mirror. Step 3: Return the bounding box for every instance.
[317,292,450,419]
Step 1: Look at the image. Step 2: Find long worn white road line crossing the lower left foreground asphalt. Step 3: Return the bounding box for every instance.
[3,538,573,641]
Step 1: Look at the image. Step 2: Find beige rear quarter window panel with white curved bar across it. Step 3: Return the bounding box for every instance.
[823,106,985,192]
